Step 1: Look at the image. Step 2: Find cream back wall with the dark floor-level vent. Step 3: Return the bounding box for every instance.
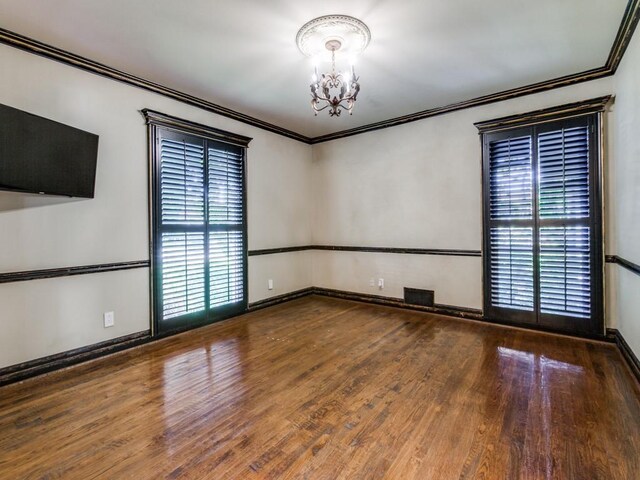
[312,78,613,308]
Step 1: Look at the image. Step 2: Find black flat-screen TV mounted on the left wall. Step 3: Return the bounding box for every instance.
[0,105,98,198]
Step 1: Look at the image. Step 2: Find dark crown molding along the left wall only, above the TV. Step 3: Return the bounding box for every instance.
[0,28,309,143]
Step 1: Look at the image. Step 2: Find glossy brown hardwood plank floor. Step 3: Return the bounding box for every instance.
[0,296,640,480]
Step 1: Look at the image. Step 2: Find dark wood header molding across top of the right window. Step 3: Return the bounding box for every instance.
[474,95,613,134]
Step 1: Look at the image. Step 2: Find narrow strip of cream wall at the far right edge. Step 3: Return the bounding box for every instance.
[611,27,640,357]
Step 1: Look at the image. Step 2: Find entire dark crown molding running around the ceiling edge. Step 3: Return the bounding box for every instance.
[0,0,640,145]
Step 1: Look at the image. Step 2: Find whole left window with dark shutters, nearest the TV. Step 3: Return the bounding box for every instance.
[143,110,250,333]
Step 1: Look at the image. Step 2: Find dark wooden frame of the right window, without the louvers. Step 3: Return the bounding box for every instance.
[475,96,612,337]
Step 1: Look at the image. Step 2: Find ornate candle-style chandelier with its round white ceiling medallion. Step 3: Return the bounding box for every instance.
[296,15,371,117]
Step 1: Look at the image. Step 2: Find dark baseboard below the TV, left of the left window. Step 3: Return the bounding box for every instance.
[0,331,151,386]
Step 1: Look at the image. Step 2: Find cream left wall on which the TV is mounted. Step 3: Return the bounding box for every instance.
[0,45,311,368]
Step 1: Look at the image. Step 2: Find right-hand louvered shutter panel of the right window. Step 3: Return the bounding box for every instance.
[538,125,592,318]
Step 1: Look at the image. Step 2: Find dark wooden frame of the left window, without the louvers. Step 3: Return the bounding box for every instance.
[141,109,252,336]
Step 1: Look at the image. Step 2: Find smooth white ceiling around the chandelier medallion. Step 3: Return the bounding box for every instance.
[0,0,627,137]
